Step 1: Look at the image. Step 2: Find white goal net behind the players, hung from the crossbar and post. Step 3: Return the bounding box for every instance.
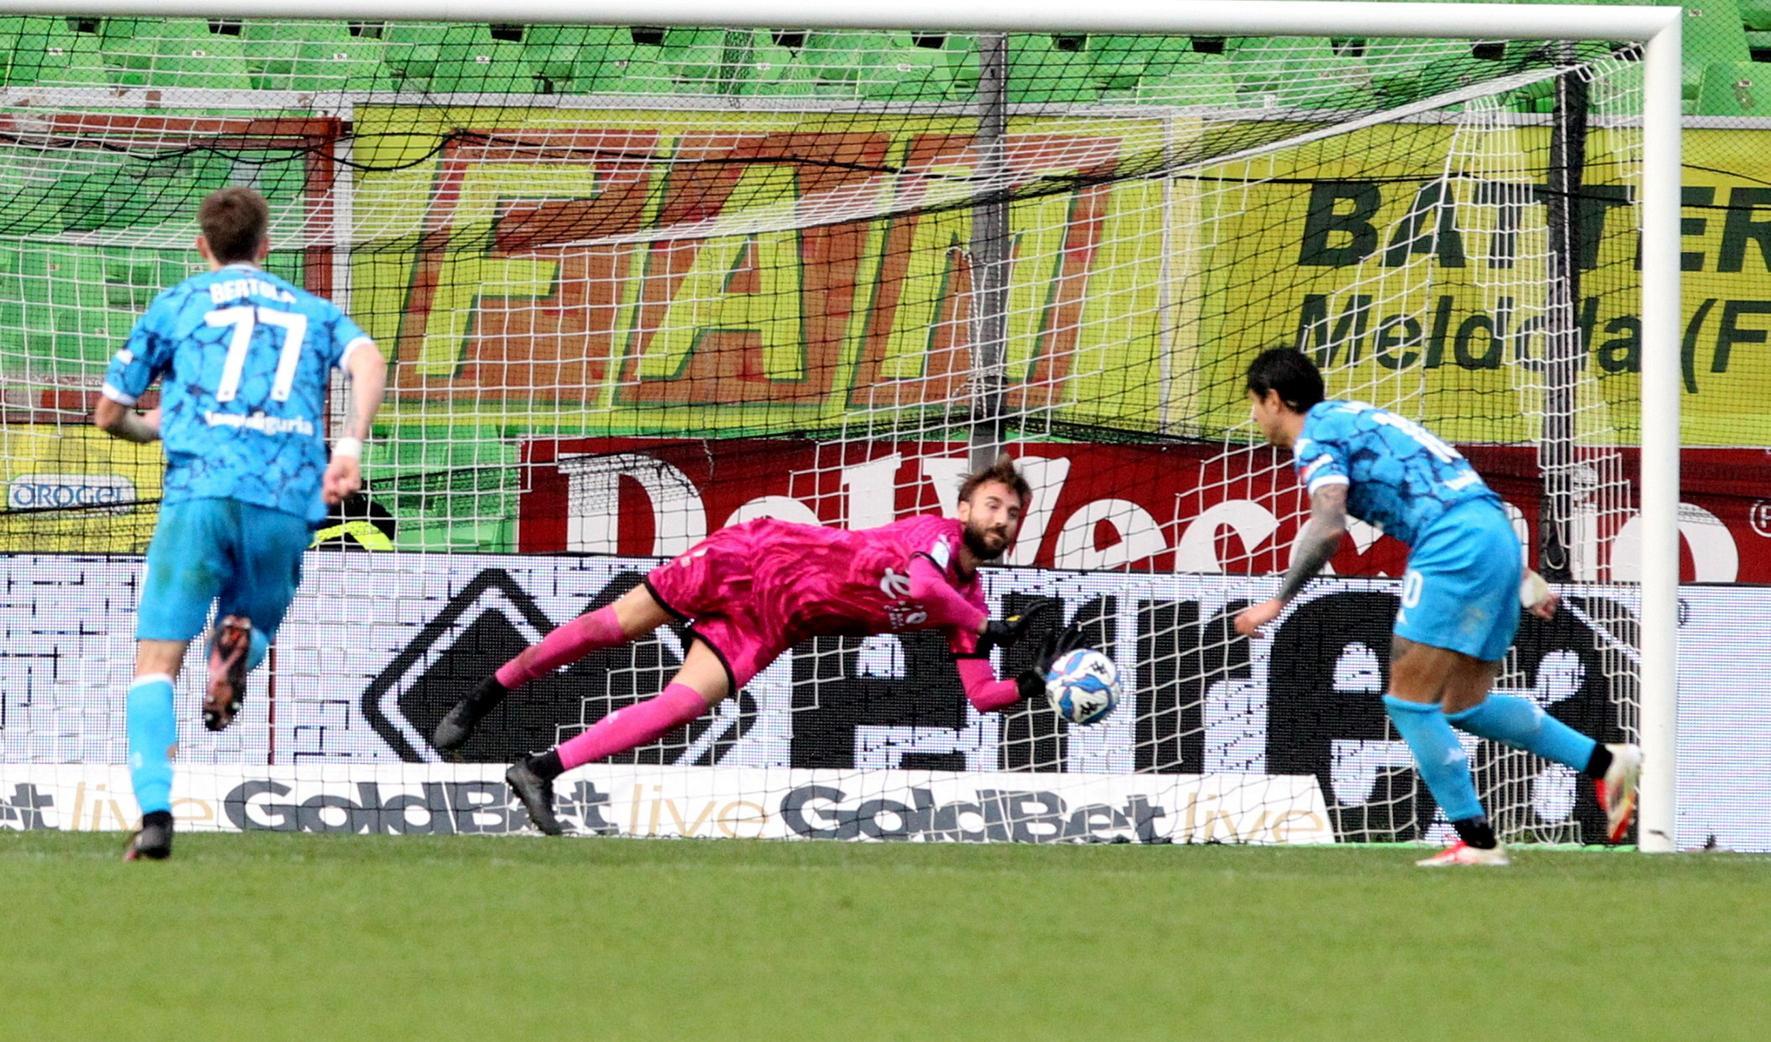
[0,18,1642,842]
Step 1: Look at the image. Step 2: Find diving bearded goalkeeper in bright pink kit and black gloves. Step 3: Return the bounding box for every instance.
[432,457,1077,835]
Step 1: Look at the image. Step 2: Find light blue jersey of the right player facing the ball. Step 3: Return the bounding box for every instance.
[1291,400,1500,546]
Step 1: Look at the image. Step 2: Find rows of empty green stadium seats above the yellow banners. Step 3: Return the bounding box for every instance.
[0,12,1771,113]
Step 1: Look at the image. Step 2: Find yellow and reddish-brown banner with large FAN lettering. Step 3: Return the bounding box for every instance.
[351,105,1165,434]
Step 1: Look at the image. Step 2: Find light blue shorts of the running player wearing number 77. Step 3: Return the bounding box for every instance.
[135,500,312,640]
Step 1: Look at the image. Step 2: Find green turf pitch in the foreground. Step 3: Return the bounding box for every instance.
[0,833,1771,1042]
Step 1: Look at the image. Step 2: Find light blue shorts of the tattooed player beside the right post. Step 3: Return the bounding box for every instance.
[1396,500,1525,663]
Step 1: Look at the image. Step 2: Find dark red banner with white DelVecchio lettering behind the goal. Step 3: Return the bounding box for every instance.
[517,438,1771,583]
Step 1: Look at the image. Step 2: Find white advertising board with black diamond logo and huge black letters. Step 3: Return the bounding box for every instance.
[0,551,1728,849]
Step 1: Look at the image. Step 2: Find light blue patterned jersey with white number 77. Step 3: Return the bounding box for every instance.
[104,264,370,525]
